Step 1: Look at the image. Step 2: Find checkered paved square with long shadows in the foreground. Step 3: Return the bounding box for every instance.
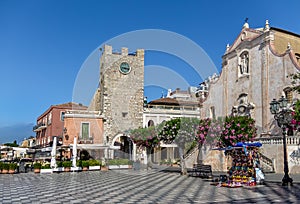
[0,170,300,203]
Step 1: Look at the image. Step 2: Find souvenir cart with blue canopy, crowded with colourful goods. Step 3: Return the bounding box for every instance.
[217,142,262,187]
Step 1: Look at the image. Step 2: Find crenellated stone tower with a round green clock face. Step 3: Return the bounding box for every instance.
[90,45,144,145]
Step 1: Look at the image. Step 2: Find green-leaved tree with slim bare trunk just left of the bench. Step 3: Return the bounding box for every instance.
[158,118,199,174]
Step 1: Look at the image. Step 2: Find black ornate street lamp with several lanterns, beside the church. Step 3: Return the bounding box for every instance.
[270,96,293,186]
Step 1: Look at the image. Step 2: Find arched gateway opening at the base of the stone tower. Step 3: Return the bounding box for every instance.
[112,135,133,160]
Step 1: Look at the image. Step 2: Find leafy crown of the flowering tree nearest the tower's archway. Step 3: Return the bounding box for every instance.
[130,126,159,148]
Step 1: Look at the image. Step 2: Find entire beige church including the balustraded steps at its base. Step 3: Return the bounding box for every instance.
[197,21,300,173]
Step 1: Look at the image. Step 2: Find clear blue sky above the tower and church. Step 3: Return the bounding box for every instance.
[0,0,300,143]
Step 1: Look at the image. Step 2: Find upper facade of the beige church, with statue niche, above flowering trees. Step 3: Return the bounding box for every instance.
[201,21,300,135]
